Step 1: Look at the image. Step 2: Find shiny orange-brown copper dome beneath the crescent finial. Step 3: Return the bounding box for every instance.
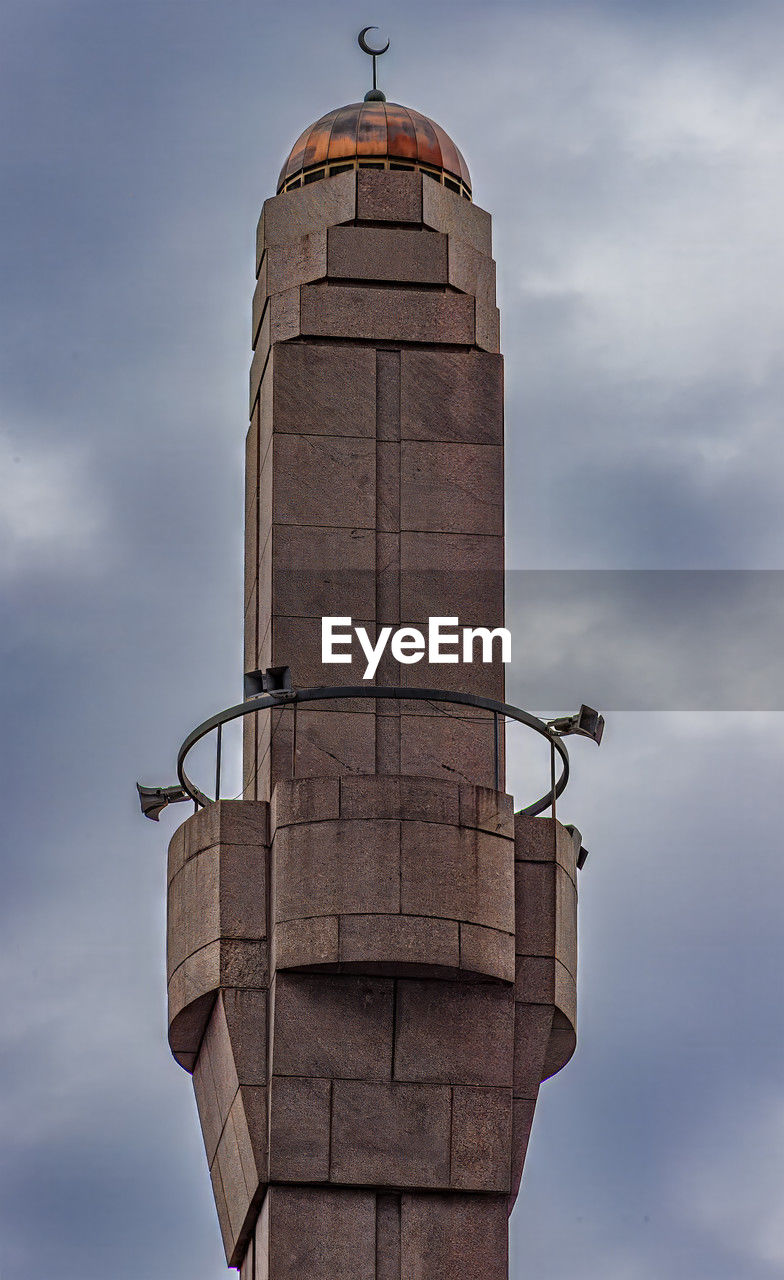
[278,101,471,200]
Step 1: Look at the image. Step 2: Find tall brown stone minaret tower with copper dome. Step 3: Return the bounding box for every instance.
[168,97,576,1280]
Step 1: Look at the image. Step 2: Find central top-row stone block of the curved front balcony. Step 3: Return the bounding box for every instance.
[341,773,460,826]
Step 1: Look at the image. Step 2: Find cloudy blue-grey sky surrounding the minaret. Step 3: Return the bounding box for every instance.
[0,0,784,1280]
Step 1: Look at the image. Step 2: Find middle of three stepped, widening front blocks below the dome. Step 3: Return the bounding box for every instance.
[327,227,448,284]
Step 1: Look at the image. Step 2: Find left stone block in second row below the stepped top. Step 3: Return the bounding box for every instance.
[264,434,375,529]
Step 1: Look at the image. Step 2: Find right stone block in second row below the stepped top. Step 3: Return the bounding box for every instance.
[400,440,503,536]
